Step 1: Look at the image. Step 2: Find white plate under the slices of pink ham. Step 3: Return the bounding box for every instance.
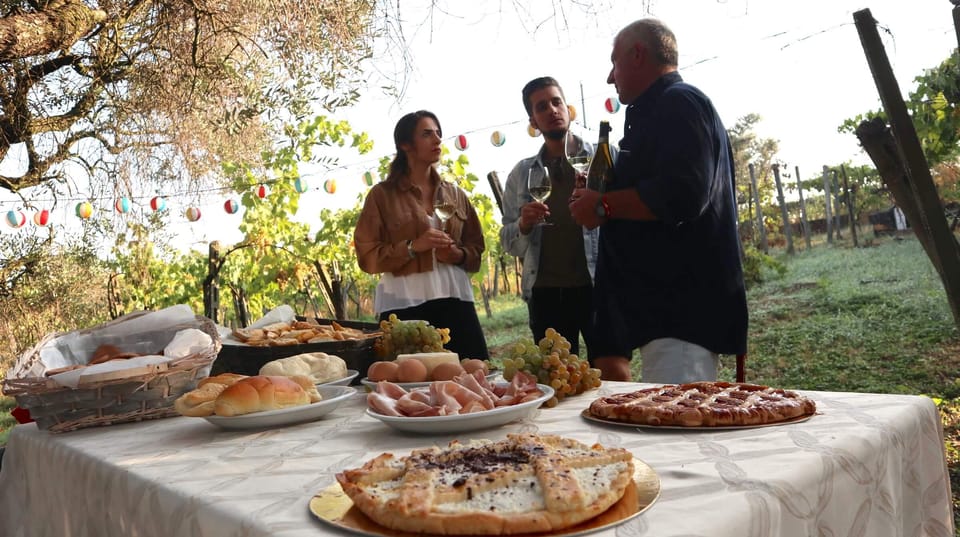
[367,384,554,434]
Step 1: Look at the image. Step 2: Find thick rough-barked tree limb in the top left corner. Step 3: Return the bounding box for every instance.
[0,0,107,61]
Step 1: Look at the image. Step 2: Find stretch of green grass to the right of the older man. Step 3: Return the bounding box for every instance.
[747,240,960,398]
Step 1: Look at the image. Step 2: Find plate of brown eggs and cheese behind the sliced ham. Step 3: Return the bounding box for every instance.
[360,352,500,390]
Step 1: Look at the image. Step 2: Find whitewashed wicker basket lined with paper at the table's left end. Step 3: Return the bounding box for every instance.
[2,312,220,433]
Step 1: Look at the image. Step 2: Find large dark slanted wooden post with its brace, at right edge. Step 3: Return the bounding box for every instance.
[853,9,960,326]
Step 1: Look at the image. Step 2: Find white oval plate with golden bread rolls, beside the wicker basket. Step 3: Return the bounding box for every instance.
[174,373,357,429]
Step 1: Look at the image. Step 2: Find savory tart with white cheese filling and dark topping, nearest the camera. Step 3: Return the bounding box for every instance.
[337,434,634,535]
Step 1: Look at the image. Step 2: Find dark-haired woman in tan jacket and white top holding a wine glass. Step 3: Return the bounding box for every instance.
[353,110,489,359]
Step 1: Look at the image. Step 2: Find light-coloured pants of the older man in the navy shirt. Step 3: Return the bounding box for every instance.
[640,338,720,384]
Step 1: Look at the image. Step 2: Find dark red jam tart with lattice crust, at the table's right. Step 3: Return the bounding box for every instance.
[587,382,817,427]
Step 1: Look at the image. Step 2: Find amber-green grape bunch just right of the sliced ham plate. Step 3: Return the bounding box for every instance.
[500,328,600,407]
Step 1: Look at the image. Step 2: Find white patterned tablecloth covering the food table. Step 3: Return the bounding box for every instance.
[0,383,953,537]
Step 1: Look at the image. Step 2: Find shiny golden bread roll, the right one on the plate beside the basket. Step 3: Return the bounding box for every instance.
[214,375,310,416]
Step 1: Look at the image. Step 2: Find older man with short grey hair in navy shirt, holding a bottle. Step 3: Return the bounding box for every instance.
[570,19,747,383]
